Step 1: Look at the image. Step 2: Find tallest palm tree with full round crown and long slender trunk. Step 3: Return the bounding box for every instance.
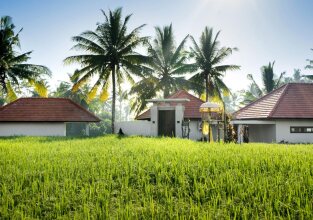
[65,8,147,132]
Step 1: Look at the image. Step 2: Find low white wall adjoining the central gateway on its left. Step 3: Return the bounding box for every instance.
[115,120,151,136]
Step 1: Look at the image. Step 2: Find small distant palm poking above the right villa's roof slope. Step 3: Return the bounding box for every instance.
[243,61,286,104]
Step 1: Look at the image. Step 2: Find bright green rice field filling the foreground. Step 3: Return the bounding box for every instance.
[0,136,313,219]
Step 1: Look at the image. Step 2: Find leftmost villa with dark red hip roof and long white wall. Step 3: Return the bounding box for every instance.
[0,98,100,136]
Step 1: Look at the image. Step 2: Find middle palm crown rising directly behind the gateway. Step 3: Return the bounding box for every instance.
[131,24,192,113]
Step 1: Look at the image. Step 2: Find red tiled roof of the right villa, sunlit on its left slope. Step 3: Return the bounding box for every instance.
[234,83,313,120]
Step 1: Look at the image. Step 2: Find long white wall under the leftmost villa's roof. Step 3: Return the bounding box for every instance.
[0,122,66,136]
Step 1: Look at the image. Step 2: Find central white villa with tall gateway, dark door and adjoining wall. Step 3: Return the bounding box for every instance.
[115,90,222,140]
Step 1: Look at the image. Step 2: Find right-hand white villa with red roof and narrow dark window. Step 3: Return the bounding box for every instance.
[232,83,313,143]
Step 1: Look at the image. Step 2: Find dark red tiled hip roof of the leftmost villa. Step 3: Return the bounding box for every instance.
[0,98,100,122]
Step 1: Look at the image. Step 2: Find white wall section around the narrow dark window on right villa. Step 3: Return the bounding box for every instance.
[276,120,313,143]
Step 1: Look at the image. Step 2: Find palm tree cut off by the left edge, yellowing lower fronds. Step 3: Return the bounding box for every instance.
[0,16,51,101]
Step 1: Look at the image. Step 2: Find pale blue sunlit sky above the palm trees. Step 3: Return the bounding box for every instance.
[0,0,313,91]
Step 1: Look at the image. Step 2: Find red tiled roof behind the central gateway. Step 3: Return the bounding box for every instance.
[136,90,204,120]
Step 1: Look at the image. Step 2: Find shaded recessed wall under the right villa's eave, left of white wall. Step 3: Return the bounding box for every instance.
[249,125,276,143]
